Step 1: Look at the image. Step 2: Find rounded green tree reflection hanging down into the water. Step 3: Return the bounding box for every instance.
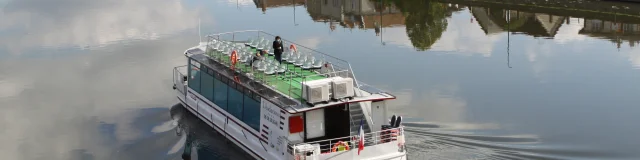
[393,0,453,51]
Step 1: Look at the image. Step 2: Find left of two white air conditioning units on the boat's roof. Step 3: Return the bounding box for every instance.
[302,79,331,104]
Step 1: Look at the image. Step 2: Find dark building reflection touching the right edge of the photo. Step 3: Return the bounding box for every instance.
[579,19,640,47]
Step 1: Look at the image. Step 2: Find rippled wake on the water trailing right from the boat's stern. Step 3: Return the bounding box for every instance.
[405,122,627,159]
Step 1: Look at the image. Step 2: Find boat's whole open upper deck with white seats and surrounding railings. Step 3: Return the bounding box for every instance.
[185,30,395,113]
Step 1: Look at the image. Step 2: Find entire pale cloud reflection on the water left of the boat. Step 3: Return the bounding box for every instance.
[0,0,198,160]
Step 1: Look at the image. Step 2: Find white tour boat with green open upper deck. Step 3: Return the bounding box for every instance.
[173,30,407,160]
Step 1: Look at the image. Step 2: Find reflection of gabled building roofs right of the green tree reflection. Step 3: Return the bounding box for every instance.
[471,7,567,37]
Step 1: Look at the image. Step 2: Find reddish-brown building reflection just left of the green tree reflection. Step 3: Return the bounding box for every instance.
[307,0,404,31]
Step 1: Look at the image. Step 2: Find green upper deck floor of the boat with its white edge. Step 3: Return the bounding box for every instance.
[185,37,395,113]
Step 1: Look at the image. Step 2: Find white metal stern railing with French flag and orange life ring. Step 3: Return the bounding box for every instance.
[287,126,404,155]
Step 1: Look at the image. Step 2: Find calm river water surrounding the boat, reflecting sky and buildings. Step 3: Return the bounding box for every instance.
[0,0,640,160]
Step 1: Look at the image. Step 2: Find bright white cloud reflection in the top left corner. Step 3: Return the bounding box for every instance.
[0,0,198,54]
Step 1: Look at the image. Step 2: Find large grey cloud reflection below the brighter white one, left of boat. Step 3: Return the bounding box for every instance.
[0,31,192,160]
